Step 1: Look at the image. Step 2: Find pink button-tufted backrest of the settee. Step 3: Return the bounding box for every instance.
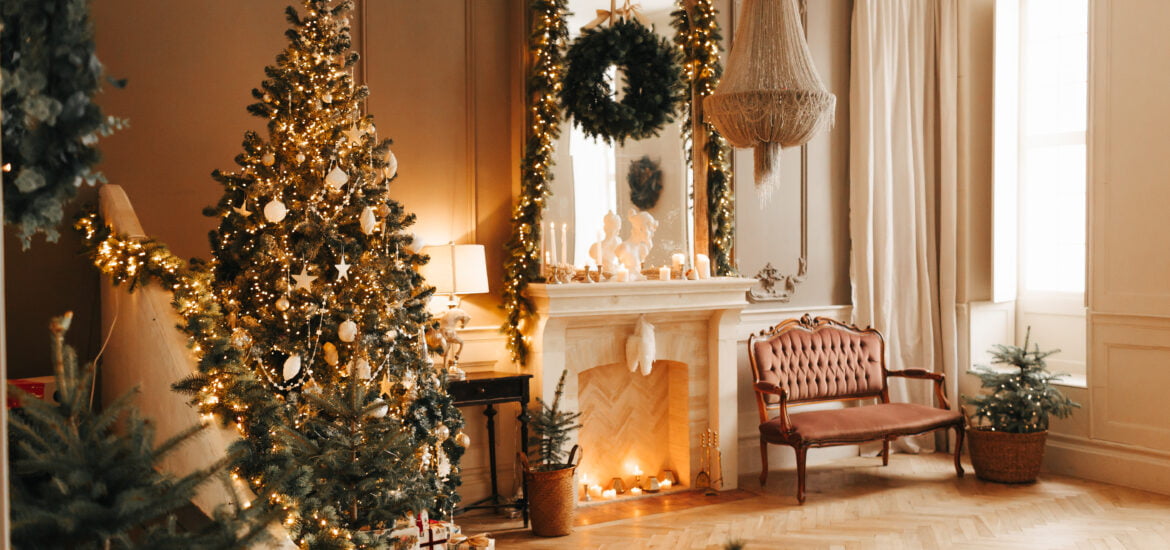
[752,325,882,403]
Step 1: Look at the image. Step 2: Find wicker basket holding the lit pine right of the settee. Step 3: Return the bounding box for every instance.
[966,428,1048,483]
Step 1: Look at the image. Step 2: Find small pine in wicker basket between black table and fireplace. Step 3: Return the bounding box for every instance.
[519,371,581,537]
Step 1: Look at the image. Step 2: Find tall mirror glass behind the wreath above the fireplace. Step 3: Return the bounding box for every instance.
[543,0,694,267]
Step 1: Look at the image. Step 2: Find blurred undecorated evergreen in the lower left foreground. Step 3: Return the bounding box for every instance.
[9,314,271,550]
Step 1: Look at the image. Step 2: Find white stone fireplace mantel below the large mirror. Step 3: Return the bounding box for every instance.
[525,277,756,489]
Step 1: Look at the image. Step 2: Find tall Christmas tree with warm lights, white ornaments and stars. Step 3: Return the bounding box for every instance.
[180,0,462,548]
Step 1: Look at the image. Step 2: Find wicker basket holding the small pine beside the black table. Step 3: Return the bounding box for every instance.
[516,445,580,537]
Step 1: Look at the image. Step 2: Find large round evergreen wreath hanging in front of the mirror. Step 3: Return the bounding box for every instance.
[560,20,683,144]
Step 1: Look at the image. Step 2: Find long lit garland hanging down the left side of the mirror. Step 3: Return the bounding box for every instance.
[501,0,569,364]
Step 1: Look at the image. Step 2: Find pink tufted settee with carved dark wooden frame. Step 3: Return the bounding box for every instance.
[748,315,963,503]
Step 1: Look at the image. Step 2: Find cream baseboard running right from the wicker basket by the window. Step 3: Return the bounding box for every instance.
[1044,432,1170,495]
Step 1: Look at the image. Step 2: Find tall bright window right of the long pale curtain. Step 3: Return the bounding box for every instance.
[993,0,1089,379]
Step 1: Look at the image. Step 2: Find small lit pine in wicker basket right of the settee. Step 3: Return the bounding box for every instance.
[963,326,1080,483]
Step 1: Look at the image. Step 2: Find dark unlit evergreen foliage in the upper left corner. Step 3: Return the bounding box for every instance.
[0,0,125,248]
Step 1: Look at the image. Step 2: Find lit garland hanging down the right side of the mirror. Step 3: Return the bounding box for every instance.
[672,0,738,276]
